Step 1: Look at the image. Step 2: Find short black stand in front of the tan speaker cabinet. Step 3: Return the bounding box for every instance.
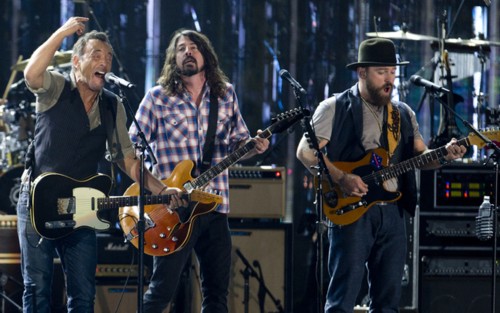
[236,249,285,313]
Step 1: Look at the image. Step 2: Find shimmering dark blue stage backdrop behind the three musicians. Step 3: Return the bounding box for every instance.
[0,0,500,312]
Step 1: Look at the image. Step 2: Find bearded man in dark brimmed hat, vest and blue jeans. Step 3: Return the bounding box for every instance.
[297,38,466,313]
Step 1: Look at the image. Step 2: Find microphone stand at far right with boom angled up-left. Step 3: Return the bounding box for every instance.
[431,91,500,313]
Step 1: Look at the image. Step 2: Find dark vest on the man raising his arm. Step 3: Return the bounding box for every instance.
[32,79,117,179]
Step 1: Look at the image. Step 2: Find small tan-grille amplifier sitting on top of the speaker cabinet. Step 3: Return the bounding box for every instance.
[229,166,286,219]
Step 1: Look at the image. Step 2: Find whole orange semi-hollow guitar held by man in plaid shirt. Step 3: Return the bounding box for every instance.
[119,109,309,256]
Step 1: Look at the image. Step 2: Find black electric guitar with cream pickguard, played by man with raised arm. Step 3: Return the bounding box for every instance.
[30,173,218,239]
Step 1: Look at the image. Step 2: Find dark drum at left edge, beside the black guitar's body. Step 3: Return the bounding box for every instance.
[0,165,24,214]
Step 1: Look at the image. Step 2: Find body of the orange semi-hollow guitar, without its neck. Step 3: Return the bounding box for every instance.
[119,160,222,256]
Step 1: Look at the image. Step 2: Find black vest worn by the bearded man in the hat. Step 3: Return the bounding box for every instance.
[327,84,417,216]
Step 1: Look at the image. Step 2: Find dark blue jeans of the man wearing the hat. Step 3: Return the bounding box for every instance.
[325,205,407,313]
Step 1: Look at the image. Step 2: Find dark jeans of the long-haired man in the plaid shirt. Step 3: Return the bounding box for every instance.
[144,212,232,313]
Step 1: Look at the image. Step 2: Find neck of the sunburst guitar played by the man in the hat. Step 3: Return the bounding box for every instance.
[363,138,470,181]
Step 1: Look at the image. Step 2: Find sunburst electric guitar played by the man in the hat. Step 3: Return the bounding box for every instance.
[315,129,500,225]
